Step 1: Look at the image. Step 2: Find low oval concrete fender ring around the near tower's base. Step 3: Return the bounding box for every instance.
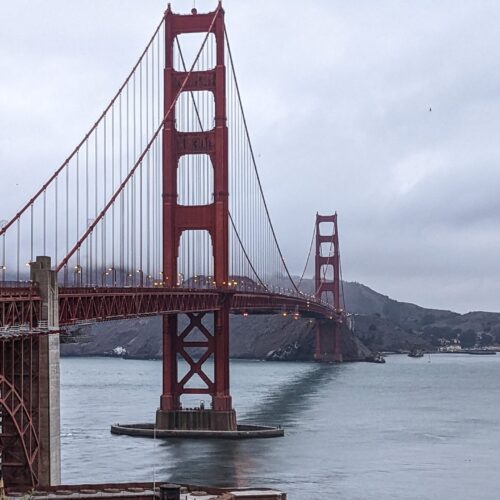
[111,424,285,439]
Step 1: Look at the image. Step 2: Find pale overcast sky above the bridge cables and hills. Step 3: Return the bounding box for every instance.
[0,0,500,312]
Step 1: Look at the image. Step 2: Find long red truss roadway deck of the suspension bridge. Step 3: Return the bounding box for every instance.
[0,286,338,327]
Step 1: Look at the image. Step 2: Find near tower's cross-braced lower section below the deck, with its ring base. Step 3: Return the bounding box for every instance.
[117,292,284,439]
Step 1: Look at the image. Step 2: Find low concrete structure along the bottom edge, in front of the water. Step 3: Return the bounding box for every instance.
[0,482,286,500]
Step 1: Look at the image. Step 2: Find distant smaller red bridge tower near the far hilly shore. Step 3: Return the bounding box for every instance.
[314,214,342,362]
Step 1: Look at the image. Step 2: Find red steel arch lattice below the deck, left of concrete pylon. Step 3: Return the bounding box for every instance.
[0,333,40,487]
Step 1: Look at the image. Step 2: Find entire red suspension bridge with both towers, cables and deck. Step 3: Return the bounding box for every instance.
[0,4,343,485]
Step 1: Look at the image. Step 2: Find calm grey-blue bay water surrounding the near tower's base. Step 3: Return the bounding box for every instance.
[61,354,500,500]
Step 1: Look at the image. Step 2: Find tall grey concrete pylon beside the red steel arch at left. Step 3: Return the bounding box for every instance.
[31,257,61,486]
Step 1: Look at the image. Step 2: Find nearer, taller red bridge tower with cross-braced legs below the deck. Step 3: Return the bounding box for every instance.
[156,3,236,430]
